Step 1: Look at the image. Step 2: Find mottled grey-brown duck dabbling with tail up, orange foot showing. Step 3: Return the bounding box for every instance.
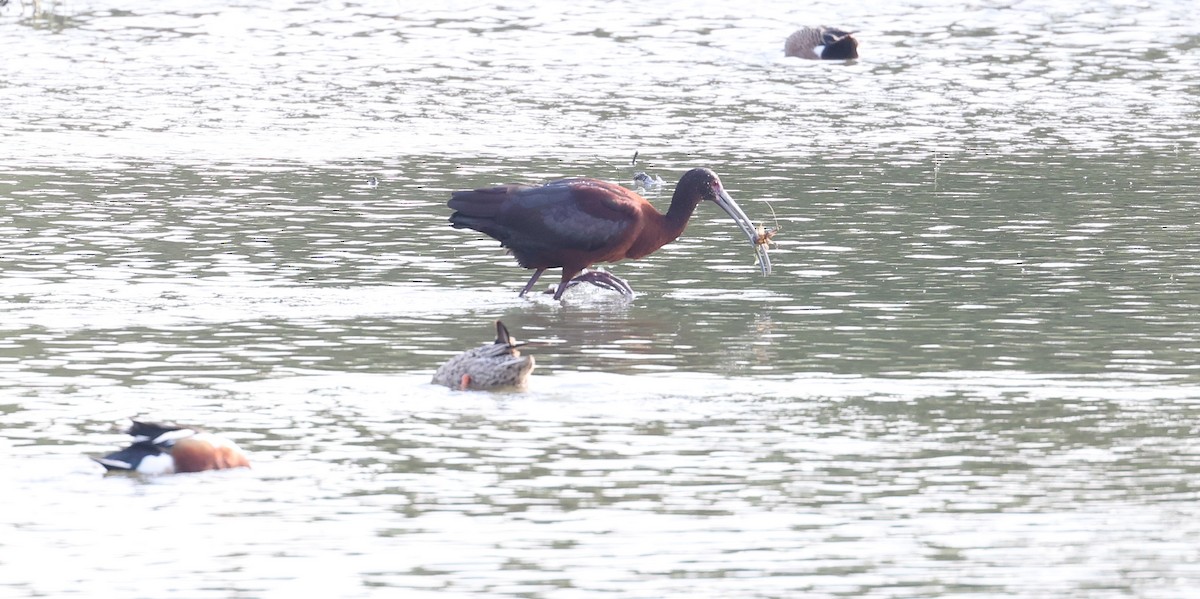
[433,321,533,390]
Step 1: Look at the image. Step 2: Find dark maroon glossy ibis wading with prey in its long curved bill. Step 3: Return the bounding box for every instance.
[450,168,770,299]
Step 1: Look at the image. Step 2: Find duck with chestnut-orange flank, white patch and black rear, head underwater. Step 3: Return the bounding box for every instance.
[92,420,250,474]
